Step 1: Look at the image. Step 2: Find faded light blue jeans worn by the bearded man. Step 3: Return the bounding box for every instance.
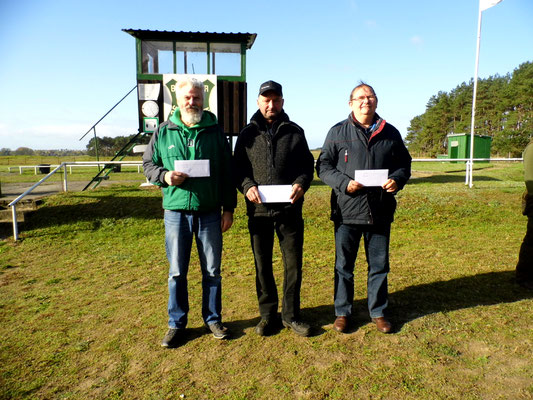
[165,210,222,328]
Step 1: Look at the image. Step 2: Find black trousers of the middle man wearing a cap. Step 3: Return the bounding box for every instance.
[248,213,304,322]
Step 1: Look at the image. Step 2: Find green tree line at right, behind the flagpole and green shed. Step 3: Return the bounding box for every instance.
[405,62,533,157]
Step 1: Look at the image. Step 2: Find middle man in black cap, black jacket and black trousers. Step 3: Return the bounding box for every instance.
[234,81,314,336]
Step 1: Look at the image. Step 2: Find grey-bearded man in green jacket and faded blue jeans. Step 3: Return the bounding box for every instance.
[143,78,237,347]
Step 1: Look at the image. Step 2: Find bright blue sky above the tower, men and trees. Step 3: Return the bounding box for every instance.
[0,0,533,150]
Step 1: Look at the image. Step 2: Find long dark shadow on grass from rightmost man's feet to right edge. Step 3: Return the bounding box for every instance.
[296,270,533,335]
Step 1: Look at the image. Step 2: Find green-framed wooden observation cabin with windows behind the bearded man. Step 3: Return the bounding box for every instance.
[123,29,257,137]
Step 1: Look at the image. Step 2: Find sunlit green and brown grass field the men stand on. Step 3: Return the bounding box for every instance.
[0,163,533,400]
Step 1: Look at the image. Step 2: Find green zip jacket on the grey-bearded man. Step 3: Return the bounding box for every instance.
[143,108,237,212]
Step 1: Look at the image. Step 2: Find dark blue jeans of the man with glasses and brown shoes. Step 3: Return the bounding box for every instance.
[334,224,390,318]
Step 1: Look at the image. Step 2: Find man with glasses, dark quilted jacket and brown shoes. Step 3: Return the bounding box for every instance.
[316,83,411,333]
